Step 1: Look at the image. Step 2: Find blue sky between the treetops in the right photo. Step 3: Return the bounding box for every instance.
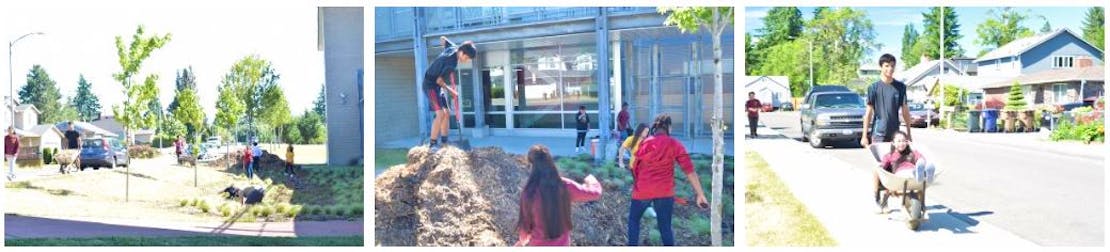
[744,7,1087,68]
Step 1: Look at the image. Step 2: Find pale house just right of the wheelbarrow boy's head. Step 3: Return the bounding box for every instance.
[895,60,967,102]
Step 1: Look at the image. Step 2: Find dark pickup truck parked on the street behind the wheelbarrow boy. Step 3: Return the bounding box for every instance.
[799,88,866,148]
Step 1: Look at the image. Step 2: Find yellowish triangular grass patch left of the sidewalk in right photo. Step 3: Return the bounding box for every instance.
[744,151,836,246]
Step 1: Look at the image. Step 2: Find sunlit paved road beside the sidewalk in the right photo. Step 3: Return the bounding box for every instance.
[760,112,1106,246]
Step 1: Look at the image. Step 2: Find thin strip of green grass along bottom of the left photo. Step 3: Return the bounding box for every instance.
[4,236,363,246]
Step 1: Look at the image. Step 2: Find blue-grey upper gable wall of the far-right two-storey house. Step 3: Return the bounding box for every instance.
[1021,32,1102,73]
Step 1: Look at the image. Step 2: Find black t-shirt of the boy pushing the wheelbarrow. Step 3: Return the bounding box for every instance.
[867,80,906,137]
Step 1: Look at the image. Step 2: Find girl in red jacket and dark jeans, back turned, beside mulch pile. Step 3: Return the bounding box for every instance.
[628,114,709,245]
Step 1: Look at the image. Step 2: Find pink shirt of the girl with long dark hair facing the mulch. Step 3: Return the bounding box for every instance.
[517,178,602,246]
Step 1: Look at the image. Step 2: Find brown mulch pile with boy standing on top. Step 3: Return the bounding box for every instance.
[374,147,647,246]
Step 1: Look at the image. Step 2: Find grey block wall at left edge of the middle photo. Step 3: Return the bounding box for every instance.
[372,52,420,145]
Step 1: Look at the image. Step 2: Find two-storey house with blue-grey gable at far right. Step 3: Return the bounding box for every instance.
[975,29,1106,109]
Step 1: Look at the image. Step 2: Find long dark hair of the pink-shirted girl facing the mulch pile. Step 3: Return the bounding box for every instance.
[516,144,574,240]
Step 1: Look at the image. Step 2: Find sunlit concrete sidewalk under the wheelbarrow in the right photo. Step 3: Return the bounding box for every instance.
[746,127,1036,248]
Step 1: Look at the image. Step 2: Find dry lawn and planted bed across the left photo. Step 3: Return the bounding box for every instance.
[4,152,364,222]
